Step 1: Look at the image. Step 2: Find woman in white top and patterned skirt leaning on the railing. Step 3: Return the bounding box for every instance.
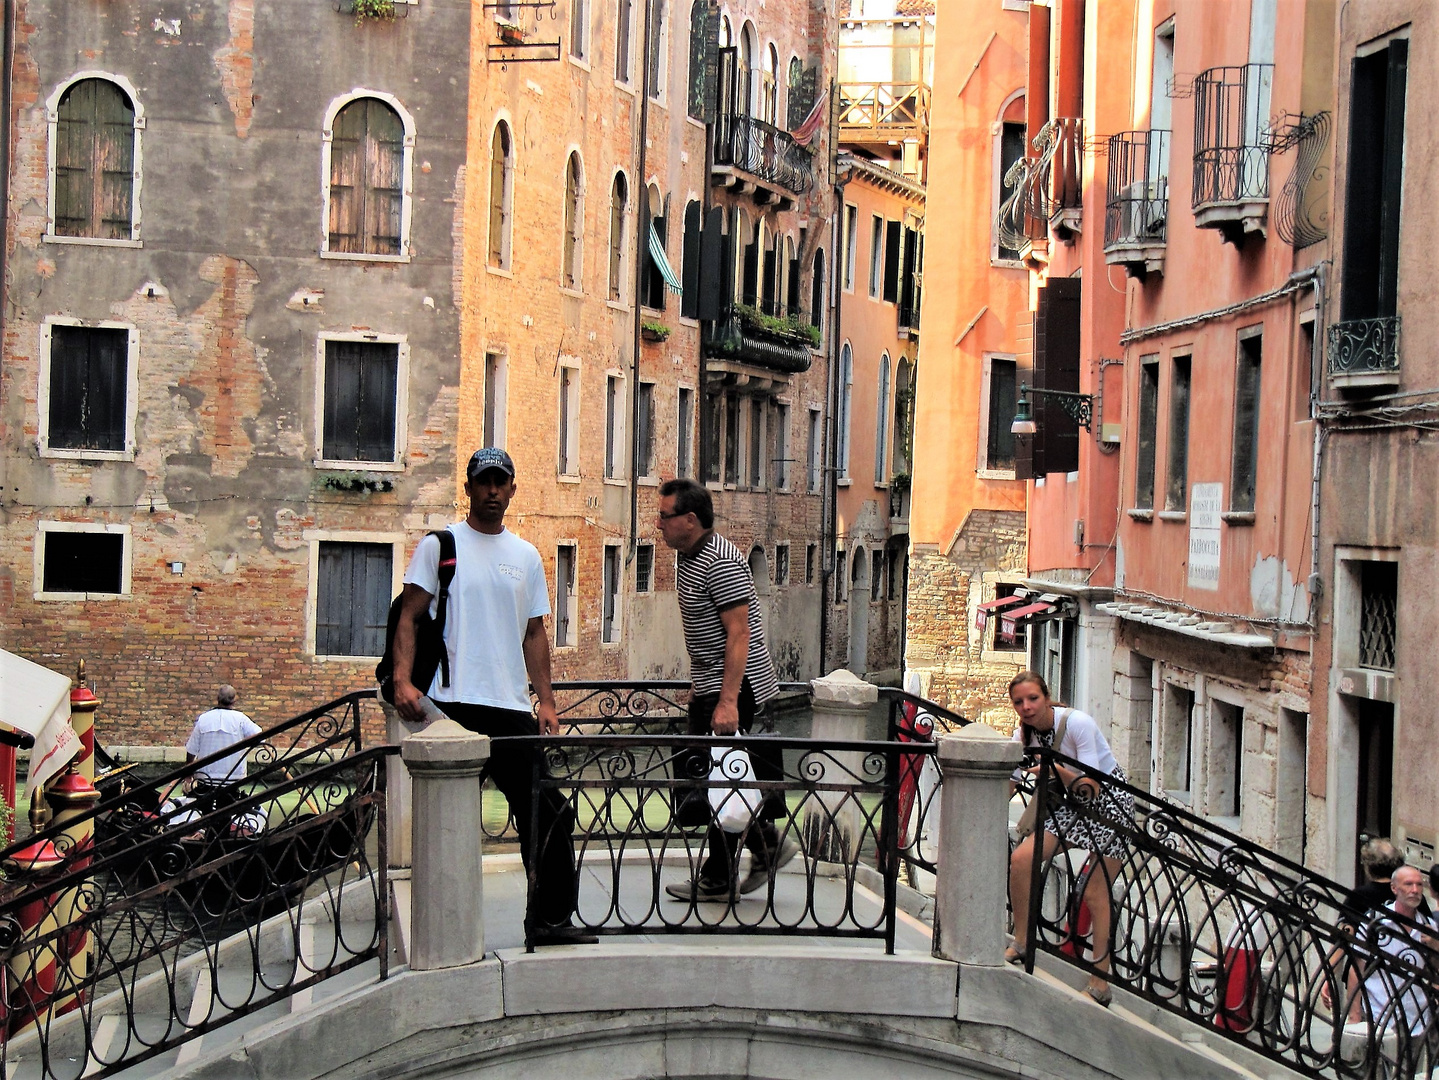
[1004,672,1134,1008]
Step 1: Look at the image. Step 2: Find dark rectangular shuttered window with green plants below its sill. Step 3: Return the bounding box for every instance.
[321,341,400,462]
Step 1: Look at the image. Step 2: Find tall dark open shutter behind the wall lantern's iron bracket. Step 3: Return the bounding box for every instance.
[1030,278,1081,477]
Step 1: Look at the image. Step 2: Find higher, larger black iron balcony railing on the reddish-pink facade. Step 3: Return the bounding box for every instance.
[1191,63,1274,210]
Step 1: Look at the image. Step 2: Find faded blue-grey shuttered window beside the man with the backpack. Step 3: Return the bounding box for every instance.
[315,541,394,656]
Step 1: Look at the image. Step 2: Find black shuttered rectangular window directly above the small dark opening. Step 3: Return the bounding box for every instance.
[47,326,130,450]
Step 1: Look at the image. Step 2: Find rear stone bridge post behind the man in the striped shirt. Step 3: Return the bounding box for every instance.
[803,669,879,863]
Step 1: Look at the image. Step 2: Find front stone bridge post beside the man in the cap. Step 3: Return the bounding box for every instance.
[400,716,489,971]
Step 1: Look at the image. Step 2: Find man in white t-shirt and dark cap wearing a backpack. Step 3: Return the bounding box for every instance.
[394,446,597,945]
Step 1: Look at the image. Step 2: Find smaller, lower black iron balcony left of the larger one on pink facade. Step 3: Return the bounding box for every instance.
[1104,129,1170,276]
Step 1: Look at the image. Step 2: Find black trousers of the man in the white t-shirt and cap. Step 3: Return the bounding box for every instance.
[435,702,578,928]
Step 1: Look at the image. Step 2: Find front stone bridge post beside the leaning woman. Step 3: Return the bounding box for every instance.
[934,723,1023,966]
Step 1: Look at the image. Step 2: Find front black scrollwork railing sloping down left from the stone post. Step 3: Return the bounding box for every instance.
[0,742,393,1080]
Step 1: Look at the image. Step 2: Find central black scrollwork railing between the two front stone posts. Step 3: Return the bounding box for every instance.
[512,735,903,952]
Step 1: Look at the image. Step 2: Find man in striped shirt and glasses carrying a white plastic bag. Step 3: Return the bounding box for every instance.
[659,480,799,902]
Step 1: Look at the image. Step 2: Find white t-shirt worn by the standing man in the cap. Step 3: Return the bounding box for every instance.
[404,522,550,713]
